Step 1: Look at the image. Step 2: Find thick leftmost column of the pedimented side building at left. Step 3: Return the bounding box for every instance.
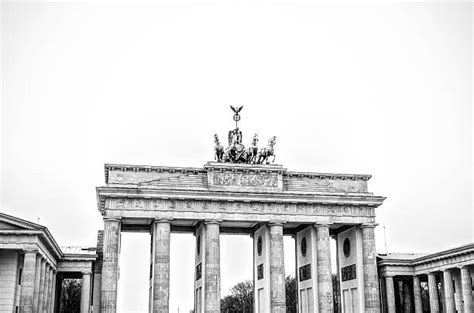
[20,250,37,313]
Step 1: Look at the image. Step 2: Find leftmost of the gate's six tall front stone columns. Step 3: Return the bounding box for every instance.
[100,218,120,313]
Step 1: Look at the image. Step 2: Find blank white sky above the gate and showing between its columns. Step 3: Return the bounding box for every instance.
[0,0,474,312]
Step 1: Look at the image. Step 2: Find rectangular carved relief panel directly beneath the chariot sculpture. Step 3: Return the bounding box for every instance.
[212,172,278,187]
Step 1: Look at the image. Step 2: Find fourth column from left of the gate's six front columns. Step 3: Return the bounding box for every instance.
[268,222,286,313]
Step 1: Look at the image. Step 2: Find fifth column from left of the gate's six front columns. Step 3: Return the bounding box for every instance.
[315,224,334,312]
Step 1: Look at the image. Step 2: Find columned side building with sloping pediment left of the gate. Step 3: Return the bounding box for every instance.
[0,213,101,313]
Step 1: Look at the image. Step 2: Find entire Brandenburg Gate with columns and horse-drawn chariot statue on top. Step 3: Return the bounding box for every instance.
[97,107,385,313]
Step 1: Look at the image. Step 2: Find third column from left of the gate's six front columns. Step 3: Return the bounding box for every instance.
[204,221,221,313]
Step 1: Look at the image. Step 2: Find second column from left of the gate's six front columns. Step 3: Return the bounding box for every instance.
[152,220,171,313]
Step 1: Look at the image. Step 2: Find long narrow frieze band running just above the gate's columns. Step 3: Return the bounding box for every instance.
[107,198,375,217]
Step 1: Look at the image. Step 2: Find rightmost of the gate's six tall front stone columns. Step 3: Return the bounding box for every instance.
[361,224,380,313]
